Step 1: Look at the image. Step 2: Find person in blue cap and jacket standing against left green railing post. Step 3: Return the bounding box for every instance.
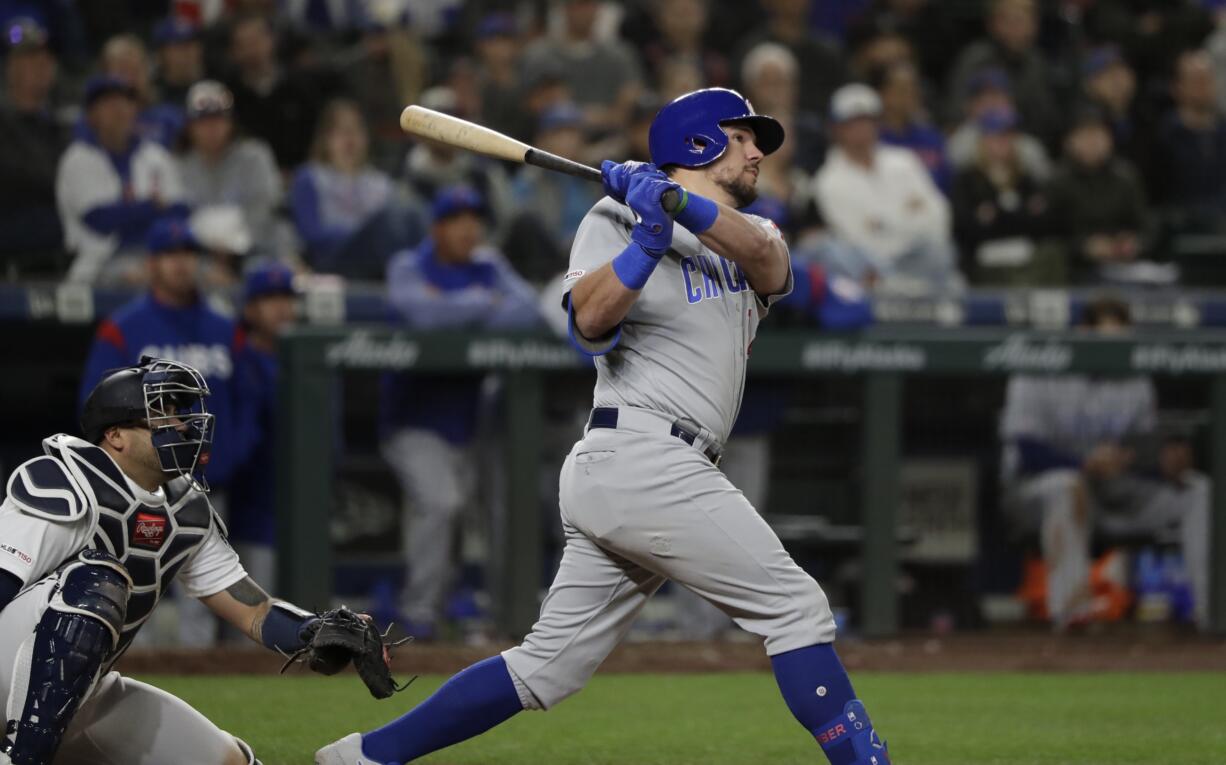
[227,262,298,587]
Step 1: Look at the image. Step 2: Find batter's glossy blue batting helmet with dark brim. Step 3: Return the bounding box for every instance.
[647,88,783,168]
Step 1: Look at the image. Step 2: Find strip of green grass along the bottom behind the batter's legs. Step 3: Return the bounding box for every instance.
[142,673,1226,765]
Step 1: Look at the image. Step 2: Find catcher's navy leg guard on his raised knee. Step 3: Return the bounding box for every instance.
[0,550,132,765]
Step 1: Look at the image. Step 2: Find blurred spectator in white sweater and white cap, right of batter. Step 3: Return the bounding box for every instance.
[814,85,964,295]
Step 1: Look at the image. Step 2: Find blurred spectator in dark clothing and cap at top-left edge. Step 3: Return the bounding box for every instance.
[0,20,67,273]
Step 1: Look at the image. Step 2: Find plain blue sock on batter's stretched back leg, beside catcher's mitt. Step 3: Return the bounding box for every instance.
[362,656,524,763]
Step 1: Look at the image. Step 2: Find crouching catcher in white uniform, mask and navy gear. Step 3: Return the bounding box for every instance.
[0,357,411,765]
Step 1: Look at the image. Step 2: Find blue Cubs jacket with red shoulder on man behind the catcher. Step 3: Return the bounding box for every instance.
[78,294,243,485]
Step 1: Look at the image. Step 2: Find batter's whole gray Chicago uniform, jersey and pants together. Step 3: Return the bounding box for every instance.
[503,199,835,709]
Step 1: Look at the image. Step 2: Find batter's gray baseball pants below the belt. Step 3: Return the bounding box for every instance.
[503,407,835,709]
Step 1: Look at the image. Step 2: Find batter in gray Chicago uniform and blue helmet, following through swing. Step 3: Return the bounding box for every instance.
[315,88,889,765]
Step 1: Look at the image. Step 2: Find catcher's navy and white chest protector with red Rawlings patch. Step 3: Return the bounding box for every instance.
[51,443,213,663]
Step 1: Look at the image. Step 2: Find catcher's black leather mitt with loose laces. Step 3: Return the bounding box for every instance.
[281,606,417,699]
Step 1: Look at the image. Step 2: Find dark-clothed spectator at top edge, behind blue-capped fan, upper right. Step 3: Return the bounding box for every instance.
[949,0,1060,146]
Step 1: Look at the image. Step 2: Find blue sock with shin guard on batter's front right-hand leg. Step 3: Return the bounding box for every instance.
[770,642,889,765]
